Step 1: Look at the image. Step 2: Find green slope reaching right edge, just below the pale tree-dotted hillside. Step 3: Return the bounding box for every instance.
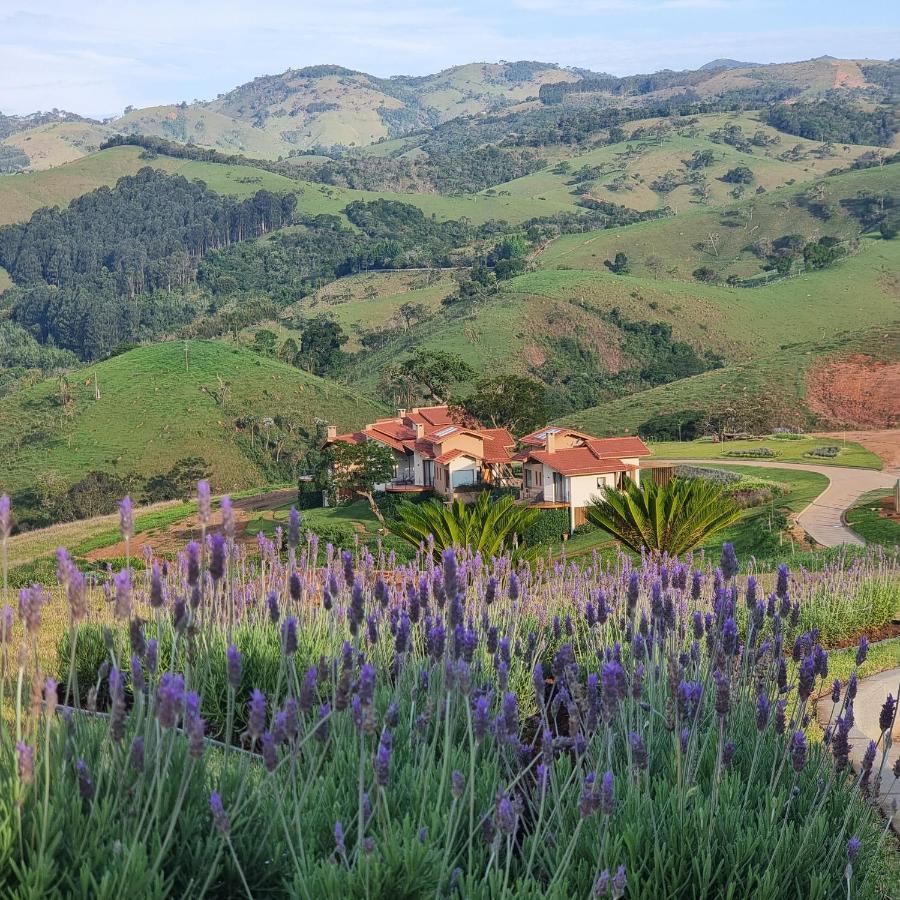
[540,165,900,280]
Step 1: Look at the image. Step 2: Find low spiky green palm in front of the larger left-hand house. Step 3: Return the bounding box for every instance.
[388,492,538,559]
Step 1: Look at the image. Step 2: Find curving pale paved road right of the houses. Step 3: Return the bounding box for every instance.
[654,459,897,547]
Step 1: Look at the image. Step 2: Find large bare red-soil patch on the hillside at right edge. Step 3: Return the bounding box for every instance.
[806,354,900,428]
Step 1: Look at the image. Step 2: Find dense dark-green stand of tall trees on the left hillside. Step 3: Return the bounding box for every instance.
[0,168,296,360]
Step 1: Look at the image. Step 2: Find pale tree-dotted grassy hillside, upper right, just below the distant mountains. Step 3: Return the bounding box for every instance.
[478,113,873,212]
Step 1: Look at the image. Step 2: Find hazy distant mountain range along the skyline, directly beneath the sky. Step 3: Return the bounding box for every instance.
[0,57,892,170]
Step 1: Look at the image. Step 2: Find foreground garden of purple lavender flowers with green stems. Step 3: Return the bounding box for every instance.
[0,489,900,898]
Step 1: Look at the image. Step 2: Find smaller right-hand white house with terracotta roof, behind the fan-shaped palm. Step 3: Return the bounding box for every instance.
[515,426,650,530]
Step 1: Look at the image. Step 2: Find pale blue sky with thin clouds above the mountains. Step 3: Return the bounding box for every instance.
[0,0,900,117]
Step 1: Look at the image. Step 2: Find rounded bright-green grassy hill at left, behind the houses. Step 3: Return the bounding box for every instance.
[0,341,382,492]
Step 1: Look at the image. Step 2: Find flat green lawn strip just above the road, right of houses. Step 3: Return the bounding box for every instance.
[650,437,884,477]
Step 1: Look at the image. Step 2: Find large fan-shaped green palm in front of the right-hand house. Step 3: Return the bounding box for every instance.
[586,478,741,555]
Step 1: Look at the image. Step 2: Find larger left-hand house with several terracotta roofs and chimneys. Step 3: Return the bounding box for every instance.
[326,406,516,499]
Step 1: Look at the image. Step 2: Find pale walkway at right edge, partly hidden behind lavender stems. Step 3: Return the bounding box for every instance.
[817,667,900,833]
